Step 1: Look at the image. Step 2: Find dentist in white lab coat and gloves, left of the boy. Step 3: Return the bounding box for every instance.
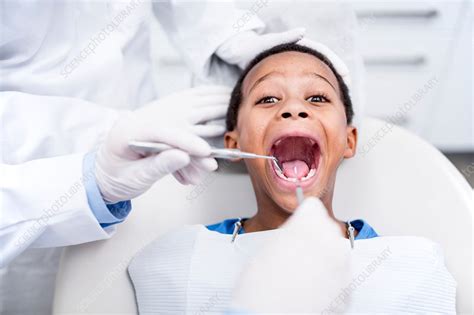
[0,0,304,313]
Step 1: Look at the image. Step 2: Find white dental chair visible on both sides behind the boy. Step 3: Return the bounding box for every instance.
[54,118,473,314]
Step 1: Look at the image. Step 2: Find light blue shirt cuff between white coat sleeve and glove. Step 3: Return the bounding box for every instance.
[83,152,132,227]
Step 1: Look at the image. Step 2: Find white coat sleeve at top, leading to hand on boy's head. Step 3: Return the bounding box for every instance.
[153,1,266,79]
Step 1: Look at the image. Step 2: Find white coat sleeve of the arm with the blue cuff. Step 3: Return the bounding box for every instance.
[0,154,114,267]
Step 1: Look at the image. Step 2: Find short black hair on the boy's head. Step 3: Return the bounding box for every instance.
[226,43,354,131]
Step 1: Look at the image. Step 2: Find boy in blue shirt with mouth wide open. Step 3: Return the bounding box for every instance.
[208,44,377,239]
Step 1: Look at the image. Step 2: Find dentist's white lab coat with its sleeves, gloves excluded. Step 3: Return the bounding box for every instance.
[0,0,263,313]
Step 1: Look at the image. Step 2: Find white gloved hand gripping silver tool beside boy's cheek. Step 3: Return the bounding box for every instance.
[95,86,231,203]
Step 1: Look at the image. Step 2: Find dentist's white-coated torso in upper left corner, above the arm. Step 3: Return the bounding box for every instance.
[0,0,155,112]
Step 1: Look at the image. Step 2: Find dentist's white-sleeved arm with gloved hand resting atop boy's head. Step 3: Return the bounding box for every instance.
[153,1,305,79]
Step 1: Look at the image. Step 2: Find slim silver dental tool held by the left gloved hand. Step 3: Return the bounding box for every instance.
[128,141,281,167]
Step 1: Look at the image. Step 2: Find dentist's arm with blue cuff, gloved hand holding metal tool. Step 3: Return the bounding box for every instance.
[0,86,230,266]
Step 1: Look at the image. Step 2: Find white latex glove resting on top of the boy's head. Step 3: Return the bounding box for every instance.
[216,28,306,69]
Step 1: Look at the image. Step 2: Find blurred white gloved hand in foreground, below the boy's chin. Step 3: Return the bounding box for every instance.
[231,197,351,314]
